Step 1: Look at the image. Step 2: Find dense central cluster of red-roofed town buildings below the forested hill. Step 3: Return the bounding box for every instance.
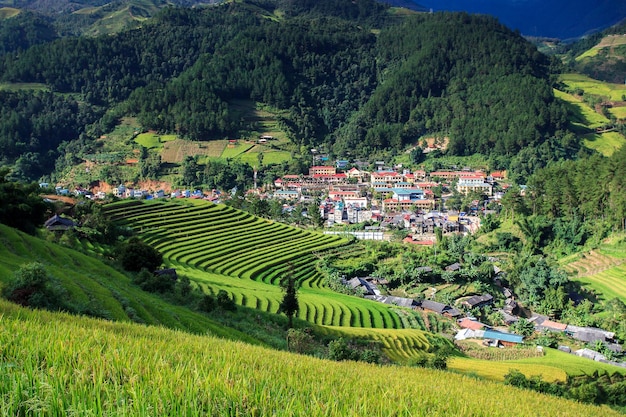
[272,161,504,234]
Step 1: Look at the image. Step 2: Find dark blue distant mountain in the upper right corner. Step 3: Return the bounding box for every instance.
[400,0,626,39]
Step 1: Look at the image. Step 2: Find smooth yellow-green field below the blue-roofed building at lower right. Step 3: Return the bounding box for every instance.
[448,348,626,382]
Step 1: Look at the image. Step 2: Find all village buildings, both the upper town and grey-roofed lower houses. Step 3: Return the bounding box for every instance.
[40,160,626,366]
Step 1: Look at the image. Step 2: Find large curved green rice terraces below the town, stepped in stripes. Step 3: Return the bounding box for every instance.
[105,200,402,329]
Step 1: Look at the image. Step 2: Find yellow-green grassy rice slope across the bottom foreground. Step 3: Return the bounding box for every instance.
[0,301,620,417]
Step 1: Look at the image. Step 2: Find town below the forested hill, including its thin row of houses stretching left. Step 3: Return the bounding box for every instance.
[45,160,502,245]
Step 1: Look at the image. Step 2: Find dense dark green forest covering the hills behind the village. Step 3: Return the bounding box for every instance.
[0,0,580,179]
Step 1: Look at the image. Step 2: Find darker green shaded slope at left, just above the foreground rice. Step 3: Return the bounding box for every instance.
[0,224,255,342]
